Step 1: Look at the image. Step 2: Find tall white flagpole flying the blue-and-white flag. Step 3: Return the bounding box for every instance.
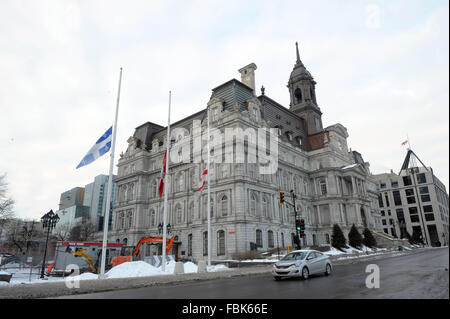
[99,68,122,278]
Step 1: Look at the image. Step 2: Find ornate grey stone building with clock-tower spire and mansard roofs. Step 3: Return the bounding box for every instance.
[109,43,382,261]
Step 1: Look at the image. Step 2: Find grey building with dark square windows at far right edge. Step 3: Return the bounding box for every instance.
[374,150,449,246]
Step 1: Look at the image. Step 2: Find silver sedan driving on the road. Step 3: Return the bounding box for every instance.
[272,249,332,280]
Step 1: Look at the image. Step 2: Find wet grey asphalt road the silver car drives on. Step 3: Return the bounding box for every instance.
[55,247,449,299]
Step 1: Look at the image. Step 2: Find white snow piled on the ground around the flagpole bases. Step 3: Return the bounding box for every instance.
[0,260,229,287]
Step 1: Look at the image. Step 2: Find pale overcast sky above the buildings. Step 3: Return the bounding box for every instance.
[0,0,449,219]
